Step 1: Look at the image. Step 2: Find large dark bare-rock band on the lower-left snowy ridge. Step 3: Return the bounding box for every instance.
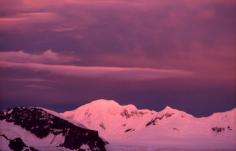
[0,107,106,151]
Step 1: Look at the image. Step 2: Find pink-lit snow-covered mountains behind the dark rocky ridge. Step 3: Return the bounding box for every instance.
[61,100,236,151]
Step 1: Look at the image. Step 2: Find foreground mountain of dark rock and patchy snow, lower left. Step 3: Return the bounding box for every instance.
[0,107,106,151]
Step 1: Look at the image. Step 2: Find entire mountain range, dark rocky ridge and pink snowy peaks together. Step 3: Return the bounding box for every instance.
[0,99,236,151]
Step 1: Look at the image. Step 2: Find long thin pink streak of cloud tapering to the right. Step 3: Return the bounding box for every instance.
[0,61,194,80]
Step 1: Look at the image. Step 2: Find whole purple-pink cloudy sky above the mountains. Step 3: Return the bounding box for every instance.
[0,0,236,116]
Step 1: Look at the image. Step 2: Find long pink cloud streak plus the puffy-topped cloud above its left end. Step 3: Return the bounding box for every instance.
[0,50,193,80]
